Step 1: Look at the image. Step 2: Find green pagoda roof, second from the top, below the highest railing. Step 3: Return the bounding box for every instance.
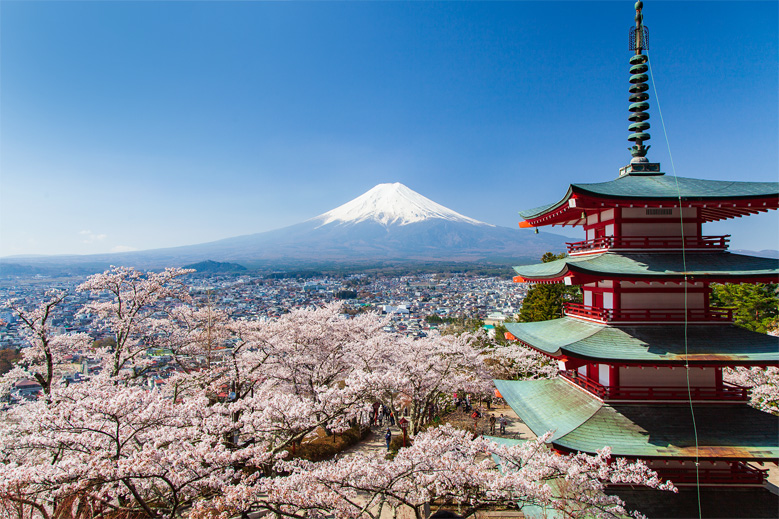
[514,252,779,284]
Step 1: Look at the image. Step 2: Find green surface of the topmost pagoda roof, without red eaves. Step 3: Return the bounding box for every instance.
[519,177,779,220]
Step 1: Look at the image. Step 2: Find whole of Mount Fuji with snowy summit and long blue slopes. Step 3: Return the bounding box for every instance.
[2,183,566,270]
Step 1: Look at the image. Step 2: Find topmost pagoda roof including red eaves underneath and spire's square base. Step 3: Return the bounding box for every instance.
[519,170,779,229]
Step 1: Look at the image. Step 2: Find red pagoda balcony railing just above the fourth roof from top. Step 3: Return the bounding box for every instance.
[560,370,749,402]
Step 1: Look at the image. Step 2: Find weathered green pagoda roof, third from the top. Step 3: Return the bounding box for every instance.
[505,317,779,366]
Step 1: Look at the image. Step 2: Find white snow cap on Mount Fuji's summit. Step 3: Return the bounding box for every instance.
[312,182,494,227]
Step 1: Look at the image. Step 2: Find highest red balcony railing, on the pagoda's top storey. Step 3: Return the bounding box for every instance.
[566,234,730,256]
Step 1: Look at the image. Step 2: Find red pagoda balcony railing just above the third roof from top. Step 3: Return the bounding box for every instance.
[563,302,733,323]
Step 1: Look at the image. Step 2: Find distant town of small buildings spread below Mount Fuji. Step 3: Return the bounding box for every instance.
[0,274,527,348]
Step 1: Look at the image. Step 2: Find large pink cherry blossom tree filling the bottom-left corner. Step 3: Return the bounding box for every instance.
[0,375,244,518]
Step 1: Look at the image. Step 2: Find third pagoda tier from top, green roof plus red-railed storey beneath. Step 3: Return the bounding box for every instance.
[506,317,779,404]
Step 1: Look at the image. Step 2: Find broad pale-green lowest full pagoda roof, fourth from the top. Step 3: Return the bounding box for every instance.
[495,378,779,460]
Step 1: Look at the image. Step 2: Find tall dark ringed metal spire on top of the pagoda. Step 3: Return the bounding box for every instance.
[628,0,650,163]
